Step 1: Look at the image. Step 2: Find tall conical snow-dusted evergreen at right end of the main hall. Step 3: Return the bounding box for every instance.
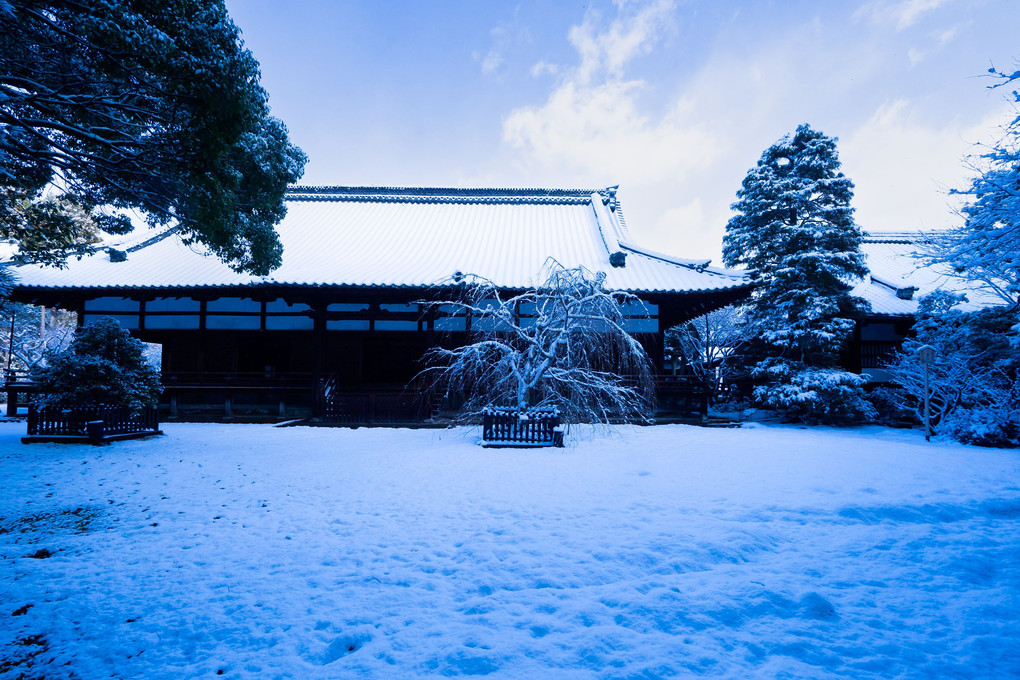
[723,124,872,422]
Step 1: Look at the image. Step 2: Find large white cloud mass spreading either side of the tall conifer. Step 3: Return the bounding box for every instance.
[493,3,1011,260]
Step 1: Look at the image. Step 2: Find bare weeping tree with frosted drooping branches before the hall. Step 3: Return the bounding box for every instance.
[420,262,652,423]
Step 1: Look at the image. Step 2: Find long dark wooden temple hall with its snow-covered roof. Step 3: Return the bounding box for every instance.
[12,187,751,421]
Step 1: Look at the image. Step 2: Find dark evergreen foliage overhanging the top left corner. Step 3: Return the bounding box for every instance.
[0,0,305,274]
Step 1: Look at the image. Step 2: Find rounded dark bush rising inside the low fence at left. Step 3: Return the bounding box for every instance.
[32,317,162,408]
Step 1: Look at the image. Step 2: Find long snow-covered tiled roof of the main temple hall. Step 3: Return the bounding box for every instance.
[9,187,749,292]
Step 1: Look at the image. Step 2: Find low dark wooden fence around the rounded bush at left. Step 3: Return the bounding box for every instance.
[27,404,159,443]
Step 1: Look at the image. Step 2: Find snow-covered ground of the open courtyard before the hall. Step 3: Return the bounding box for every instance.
[0,423,1020,679]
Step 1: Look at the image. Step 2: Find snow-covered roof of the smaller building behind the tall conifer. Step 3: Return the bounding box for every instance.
[854,231,1003,316]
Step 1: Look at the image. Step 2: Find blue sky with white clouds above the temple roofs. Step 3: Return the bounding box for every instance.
[227,0,1020,259]
